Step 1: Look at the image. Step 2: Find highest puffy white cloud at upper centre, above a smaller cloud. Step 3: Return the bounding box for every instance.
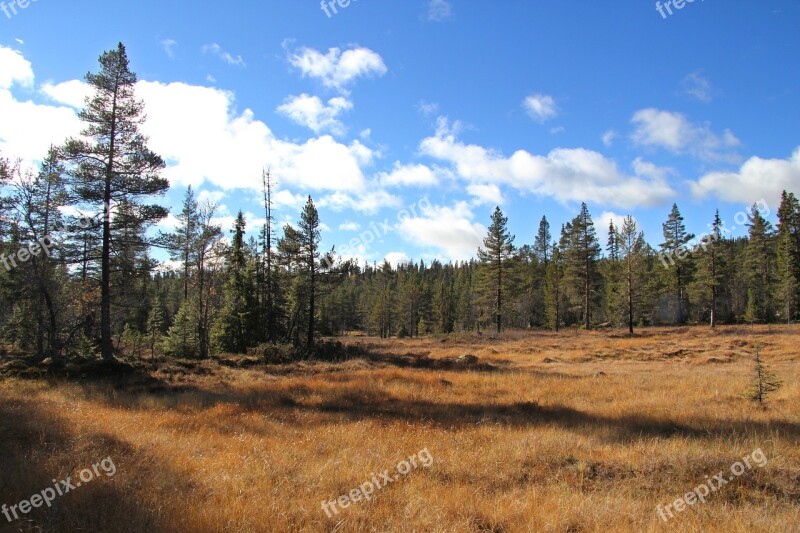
[289,47,388,93]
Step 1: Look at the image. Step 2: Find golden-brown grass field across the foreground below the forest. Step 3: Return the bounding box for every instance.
[0,326,800,532]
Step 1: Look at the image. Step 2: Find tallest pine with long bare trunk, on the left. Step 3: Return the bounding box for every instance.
[64,43,169,360]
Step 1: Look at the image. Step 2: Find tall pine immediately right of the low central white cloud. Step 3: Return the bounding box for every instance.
[478,206,514,333]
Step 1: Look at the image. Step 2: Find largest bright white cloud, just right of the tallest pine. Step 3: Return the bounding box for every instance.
[137,78,372,193]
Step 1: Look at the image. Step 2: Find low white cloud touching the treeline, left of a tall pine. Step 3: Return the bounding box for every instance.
[397,202,486,260]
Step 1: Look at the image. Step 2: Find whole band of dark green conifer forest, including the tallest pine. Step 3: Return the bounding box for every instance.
[0,44,800,360]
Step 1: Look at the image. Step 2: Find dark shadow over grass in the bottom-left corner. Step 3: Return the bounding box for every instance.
[0,386,192,532]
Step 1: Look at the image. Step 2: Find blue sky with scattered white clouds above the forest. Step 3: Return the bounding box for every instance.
[0,0,800,264]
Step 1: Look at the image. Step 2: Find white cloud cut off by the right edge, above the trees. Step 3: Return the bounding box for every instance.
[690,147,800,206]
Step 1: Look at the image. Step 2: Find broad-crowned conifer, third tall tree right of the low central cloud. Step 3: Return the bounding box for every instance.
[564,203,600,329]
